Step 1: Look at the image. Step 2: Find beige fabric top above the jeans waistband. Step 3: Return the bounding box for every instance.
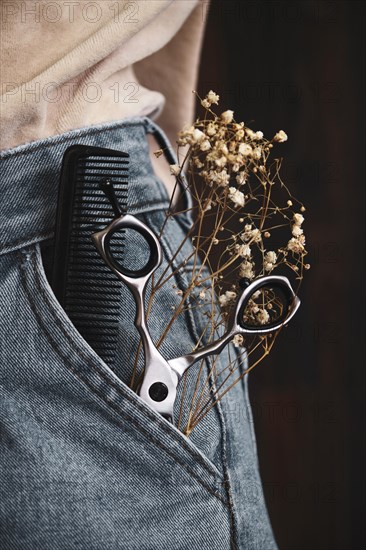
[0,0,208,149]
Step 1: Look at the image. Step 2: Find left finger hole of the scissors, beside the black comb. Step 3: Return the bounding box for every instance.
[107,227,157,278]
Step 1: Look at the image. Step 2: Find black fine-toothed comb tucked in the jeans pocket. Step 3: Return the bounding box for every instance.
[51,145,129,367]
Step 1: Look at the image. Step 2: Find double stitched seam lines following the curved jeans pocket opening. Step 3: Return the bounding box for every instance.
[18,251,228,506]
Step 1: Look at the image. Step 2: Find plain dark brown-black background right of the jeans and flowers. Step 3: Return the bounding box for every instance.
[198,0,365,550]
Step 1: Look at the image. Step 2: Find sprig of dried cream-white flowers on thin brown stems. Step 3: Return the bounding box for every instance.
[130,90,310,435]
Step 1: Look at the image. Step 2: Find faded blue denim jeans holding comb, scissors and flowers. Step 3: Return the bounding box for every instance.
[0,118,276,550]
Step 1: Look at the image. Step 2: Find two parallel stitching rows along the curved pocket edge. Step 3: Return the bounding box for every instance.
[17,246,228,500]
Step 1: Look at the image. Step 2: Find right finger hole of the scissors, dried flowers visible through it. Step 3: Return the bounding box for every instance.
[238,284,294,331]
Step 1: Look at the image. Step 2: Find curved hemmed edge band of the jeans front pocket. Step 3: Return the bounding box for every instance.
[15,245,224,498]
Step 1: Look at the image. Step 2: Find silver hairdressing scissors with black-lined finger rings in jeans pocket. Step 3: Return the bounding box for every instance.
[92,180,300,422]
